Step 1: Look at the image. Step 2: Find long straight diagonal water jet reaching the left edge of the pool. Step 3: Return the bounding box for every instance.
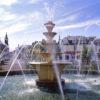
[0,46,24,91]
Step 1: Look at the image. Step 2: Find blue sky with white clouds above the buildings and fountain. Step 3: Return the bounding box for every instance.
[0,0,100,50]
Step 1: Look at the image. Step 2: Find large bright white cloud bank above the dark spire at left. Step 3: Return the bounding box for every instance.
[0,11,43,37]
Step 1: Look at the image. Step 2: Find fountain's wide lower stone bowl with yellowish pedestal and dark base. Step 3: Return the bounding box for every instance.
[29,61,72,90]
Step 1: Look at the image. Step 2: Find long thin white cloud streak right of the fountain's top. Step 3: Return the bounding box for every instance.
[55,19,100,30]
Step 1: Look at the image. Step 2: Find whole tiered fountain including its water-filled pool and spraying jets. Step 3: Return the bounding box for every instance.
[0,21,100,100]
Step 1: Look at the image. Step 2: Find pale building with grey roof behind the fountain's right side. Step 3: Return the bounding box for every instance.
[60,36,95,61]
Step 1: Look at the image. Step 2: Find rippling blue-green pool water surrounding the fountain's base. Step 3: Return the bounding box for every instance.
[0,74,100,100]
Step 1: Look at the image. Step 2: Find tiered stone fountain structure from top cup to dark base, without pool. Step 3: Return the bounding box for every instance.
[30,21,71,89]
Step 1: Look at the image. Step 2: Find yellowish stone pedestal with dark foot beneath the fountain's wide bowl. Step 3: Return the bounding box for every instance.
[36,63,61,88]
